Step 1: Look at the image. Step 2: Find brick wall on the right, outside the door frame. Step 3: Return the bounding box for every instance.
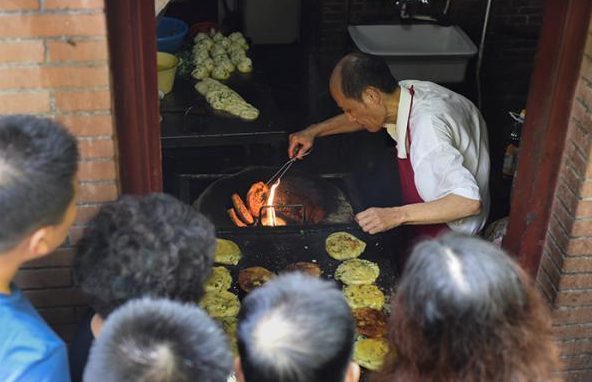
[537,14,592,382]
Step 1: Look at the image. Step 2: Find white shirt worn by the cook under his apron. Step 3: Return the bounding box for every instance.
[385,80,490,233]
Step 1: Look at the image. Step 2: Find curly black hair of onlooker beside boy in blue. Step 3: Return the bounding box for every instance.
[74,194,216,318]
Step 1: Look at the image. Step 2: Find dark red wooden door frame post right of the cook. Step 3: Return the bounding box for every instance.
[503,0,592,276]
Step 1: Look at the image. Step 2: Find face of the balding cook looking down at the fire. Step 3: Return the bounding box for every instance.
[329,71,386,133]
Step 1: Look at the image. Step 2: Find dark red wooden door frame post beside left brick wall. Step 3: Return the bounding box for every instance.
[105,0,163,194]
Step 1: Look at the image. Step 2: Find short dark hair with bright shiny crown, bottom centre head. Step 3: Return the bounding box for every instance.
[237,273,355,382]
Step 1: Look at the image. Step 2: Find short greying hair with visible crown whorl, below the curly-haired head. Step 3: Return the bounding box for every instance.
[84,298,232,382]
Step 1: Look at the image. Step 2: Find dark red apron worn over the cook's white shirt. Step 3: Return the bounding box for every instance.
[397,87,449,243]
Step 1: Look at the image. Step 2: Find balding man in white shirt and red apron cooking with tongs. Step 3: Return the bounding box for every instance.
[288,53,489,237]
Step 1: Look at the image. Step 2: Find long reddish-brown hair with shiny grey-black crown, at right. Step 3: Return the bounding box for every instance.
[374,234,559,382]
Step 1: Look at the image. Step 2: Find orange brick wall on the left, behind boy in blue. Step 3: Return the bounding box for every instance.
[0,0,118,340]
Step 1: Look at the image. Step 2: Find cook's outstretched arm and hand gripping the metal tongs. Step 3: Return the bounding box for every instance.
[288,114,364,159]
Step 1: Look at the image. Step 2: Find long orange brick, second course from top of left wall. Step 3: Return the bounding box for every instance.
[0,13,107,38]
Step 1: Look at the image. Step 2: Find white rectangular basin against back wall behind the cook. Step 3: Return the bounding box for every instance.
[347,24,477,82]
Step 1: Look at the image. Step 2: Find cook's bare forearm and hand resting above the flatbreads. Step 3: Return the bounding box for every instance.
[356,194,481,234]
